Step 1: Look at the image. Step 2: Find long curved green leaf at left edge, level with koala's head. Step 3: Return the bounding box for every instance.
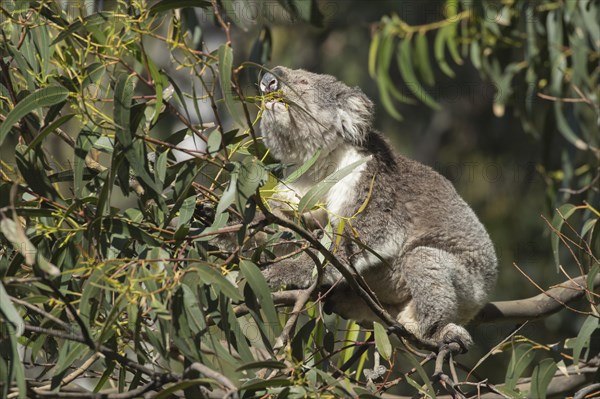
[0,86,69,145]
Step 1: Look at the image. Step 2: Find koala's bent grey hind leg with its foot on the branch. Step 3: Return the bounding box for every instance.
[397,247,473,350]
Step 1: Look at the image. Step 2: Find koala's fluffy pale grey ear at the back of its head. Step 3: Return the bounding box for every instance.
[337,87,373,144]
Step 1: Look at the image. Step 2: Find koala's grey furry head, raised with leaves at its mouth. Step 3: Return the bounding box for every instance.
[260,66,373,163]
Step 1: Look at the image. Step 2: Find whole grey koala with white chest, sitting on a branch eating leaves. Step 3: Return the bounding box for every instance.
[259,66,497,350]
